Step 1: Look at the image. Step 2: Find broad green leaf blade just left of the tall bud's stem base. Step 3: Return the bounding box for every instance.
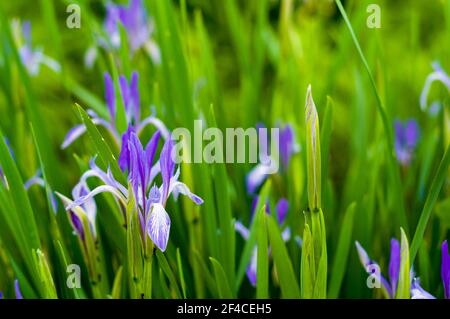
[266,216,300,298]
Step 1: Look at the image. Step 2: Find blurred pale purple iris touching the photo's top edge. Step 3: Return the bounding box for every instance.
[100,0,161,64]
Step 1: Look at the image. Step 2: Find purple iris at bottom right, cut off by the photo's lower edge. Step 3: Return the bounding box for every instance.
[355,238,433,299]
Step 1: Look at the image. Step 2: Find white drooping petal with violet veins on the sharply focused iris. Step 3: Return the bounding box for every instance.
[147,203,170,251]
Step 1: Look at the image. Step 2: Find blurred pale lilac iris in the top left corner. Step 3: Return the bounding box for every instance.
[12,20,61,76]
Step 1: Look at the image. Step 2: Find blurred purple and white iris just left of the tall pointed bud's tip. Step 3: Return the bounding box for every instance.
[246,124,299,194]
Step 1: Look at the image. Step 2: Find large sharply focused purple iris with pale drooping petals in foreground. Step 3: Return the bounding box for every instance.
[62,127,203,251]
